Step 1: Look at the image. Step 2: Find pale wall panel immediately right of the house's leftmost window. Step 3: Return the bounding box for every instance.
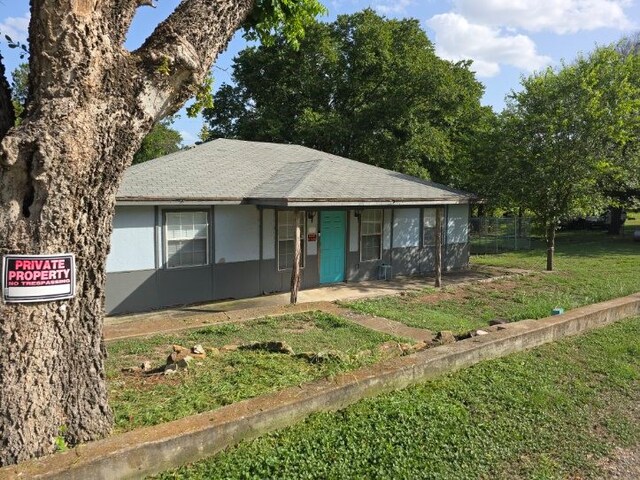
[213,205,260,263]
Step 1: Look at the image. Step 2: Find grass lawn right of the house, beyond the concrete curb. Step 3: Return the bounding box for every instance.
[346,229,640,333]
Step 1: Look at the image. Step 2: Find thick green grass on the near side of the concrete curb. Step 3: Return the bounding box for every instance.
[152,318,640,479]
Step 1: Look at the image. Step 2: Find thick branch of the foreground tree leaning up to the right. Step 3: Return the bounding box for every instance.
[133,0,255,121]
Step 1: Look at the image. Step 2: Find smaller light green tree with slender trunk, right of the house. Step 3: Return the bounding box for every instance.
[493,40,640,270]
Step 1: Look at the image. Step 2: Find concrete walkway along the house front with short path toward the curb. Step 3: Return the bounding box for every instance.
[104,267,516,341]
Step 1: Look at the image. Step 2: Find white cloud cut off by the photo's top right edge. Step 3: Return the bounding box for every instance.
[454,0,633,34]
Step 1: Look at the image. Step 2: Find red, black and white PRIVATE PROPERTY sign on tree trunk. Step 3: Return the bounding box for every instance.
[2,253,76,303]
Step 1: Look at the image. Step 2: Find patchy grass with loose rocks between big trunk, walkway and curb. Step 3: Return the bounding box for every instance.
[107,312,405,432]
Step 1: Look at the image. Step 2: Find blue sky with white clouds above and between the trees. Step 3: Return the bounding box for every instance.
[0,0,640,145]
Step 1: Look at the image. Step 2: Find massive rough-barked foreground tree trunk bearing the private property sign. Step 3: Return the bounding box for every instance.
[0,0,253,465]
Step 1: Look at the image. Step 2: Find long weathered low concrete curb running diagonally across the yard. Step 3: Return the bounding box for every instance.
[0,293,640,480]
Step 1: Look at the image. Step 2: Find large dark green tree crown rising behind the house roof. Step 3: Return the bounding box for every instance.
[204,10,490,185]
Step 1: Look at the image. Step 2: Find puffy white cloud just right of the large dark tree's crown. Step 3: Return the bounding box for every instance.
[427,13,551,77]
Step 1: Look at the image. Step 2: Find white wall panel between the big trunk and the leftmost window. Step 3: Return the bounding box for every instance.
[107,207,156,273]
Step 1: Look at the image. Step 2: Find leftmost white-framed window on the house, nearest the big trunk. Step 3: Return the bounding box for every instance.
[164,211,209,268]
